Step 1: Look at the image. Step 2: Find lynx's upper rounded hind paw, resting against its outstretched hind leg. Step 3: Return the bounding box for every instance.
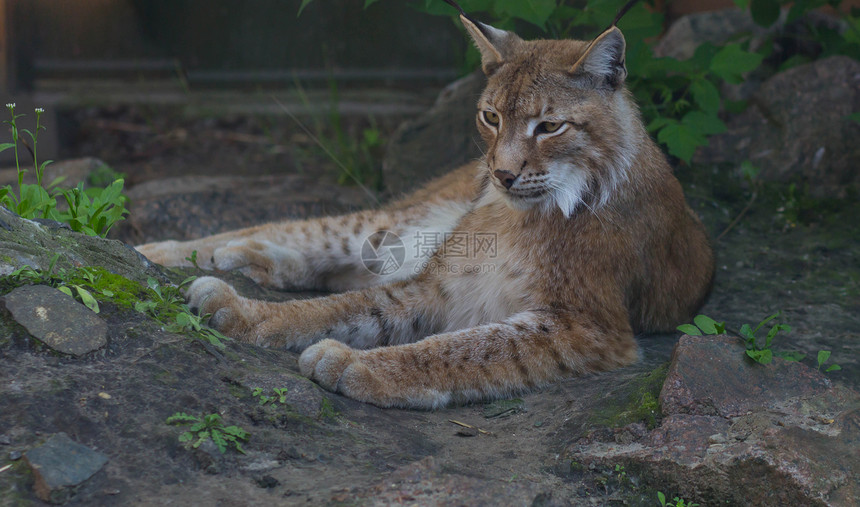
[212,239,304,289]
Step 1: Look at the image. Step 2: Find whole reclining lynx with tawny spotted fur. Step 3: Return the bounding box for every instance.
[138,9,714,408]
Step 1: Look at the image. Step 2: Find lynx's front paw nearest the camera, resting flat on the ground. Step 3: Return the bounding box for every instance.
[299,340,390,407]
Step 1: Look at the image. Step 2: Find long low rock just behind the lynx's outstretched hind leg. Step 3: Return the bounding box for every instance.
[111,174,375,244]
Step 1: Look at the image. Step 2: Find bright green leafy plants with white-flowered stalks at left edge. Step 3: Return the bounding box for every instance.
[0,104,128,237]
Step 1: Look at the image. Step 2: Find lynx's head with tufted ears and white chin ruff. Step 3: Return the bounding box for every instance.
[461,16,644,217]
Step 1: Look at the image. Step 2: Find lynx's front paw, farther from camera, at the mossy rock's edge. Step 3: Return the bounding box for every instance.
[186,276,251,341]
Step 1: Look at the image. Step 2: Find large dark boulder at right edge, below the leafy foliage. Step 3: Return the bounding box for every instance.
[696,56,860,197]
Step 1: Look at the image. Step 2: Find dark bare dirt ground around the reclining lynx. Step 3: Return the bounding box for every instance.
[0,102,860,506]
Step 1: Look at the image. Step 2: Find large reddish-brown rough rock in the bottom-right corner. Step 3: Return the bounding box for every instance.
[570,336,860,506]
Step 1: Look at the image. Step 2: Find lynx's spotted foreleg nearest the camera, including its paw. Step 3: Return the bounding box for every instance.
[299,311,637,408]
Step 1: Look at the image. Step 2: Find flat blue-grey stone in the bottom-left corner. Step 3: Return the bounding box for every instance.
[24,433,108,503]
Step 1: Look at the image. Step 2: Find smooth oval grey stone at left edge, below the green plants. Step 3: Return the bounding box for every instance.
[0,285,108,356]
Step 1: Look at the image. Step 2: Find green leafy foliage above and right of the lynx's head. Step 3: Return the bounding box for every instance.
[299,0,860,162]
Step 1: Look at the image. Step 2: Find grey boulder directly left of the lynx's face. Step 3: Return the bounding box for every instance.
[382,71,487,195]
